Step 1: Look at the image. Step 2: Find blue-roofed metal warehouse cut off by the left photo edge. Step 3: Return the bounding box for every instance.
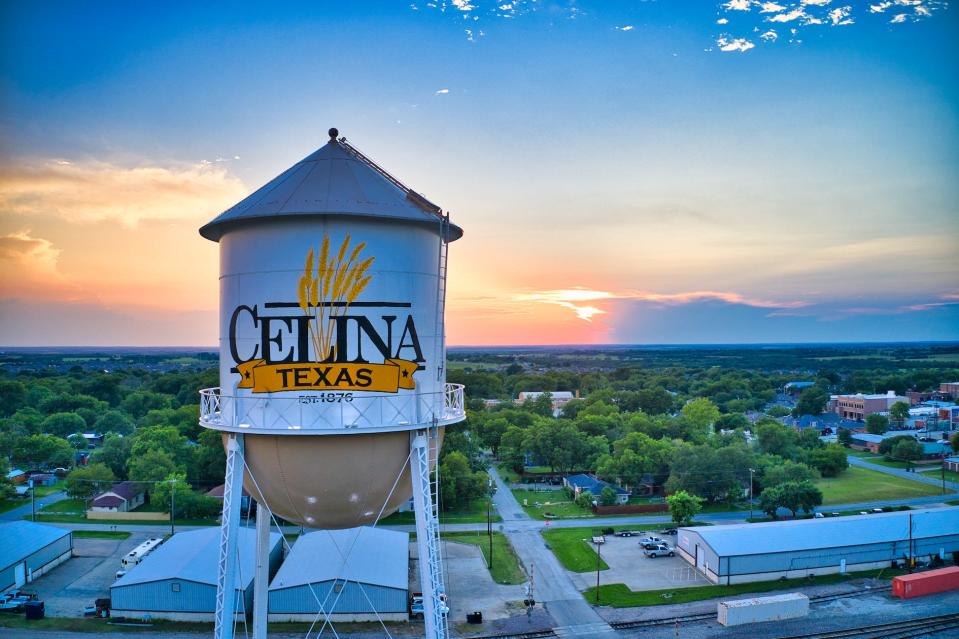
[0,521,73,592]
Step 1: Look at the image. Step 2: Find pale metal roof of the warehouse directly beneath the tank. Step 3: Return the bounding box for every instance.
[270,526,410,590]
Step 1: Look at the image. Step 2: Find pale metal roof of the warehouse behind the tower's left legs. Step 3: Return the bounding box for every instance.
[112,526,280,590]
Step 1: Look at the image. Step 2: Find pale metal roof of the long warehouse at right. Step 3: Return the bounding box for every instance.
[679,506,959,556]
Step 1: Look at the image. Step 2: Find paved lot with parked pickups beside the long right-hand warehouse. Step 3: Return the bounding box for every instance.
[570,533,709,590]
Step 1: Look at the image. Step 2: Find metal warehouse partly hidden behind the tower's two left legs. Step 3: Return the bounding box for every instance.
[110,527,283,621]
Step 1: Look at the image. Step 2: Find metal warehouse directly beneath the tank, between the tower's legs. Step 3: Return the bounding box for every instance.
[269,527,410,621]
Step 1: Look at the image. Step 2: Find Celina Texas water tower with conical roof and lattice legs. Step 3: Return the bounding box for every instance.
[200,129,465,639]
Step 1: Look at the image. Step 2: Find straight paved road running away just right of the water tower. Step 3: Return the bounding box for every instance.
[489,467,615,639]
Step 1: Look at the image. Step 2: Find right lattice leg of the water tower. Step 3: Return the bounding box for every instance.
[410,430,446,639]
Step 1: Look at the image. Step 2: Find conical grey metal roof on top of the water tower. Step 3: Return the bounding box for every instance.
[200,134,463,242]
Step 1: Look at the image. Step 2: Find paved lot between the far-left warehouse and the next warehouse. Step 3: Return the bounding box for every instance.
[29,533,150,617]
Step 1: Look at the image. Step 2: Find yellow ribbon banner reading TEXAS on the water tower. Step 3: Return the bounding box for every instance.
[237,359,417,393]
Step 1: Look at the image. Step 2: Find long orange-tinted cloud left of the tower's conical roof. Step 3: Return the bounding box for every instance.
[0,161,249,227]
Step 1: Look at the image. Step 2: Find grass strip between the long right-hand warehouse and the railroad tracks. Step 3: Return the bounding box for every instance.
[583,568,905,608]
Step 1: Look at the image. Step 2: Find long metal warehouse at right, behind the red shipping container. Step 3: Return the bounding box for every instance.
[676,507,959,584]
